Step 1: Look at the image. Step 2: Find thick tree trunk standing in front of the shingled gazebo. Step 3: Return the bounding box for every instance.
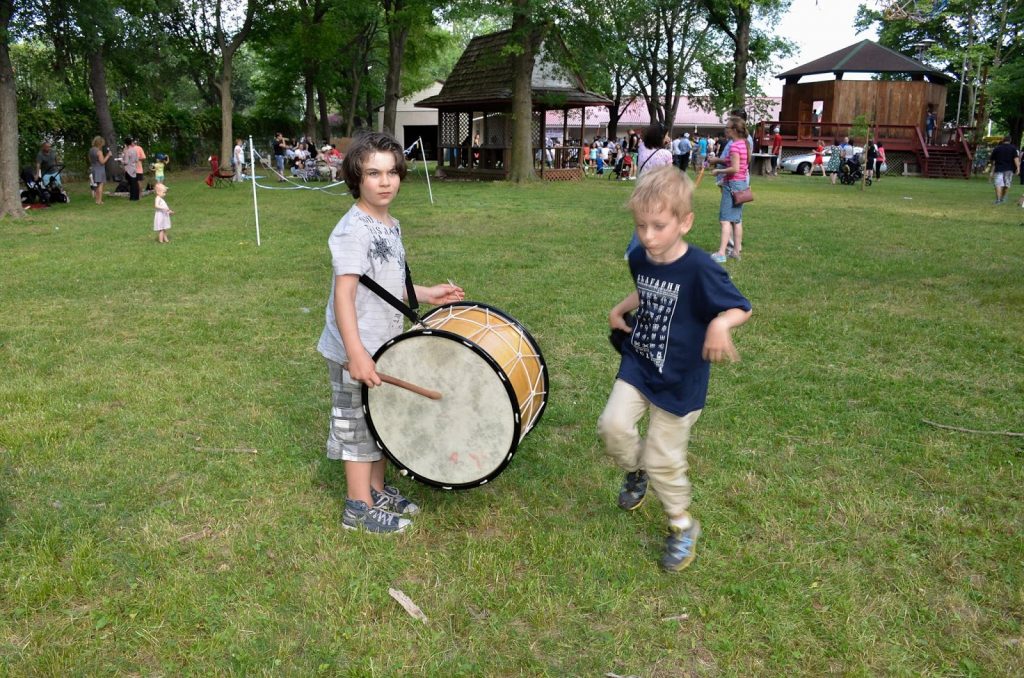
[509,0,540,183]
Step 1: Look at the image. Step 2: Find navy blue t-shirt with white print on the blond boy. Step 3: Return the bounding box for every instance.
[617,245,751,417]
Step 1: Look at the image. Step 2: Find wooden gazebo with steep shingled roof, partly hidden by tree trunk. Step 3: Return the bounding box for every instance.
[416,31,611,180]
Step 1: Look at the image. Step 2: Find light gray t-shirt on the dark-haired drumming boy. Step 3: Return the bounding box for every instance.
[316,205,406,363]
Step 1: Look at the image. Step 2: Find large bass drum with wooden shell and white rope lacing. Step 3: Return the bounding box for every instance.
[362,301,548,490]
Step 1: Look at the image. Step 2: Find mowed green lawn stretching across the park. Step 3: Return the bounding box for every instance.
[0,165,1024,677]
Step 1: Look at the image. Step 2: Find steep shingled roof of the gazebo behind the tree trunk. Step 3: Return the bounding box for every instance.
[416,31,611,109]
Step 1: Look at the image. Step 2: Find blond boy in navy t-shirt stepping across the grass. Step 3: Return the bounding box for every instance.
[598,166,751,571]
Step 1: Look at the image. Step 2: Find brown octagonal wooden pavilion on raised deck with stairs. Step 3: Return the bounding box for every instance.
[770,40,972,178]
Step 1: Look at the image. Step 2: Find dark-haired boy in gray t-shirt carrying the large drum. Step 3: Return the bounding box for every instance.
[316,132,464,534]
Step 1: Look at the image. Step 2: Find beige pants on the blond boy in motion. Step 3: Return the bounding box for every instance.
[597,379,701,517]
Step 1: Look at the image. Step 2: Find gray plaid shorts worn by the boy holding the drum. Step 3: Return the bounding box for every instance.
[327,361,383,462]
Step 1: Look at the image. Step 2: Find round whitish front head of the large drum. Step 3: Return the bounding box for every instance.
[362,330,520,490]
